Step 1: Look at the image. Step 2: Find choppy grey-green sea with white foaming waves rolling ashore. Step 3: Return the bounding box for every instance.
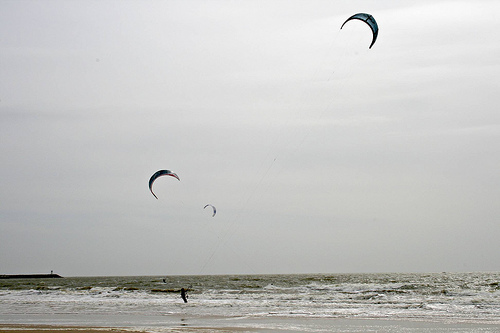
[0,272,500,332]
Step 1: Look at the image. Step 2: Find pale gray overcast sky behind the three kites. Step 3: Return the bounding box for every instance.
[0,0,500,276]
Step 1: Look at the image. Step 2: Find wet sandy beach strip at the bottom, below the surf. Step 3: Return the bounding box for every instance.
[0,317,500,333]
